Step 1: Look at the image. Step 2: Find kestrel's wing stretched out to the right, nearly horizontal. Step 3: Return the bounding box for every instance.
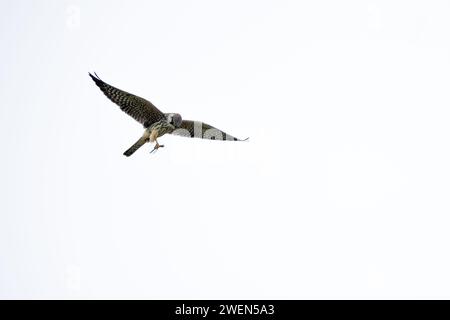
[171,120,248,141]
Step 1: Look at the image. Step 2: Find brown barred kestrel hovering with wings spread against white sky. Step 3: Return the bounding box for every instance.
[89,72,248,157]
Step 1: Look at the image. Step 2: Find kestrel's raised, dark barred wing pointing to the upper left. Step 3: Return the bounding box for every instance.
[89,73,165,127]
